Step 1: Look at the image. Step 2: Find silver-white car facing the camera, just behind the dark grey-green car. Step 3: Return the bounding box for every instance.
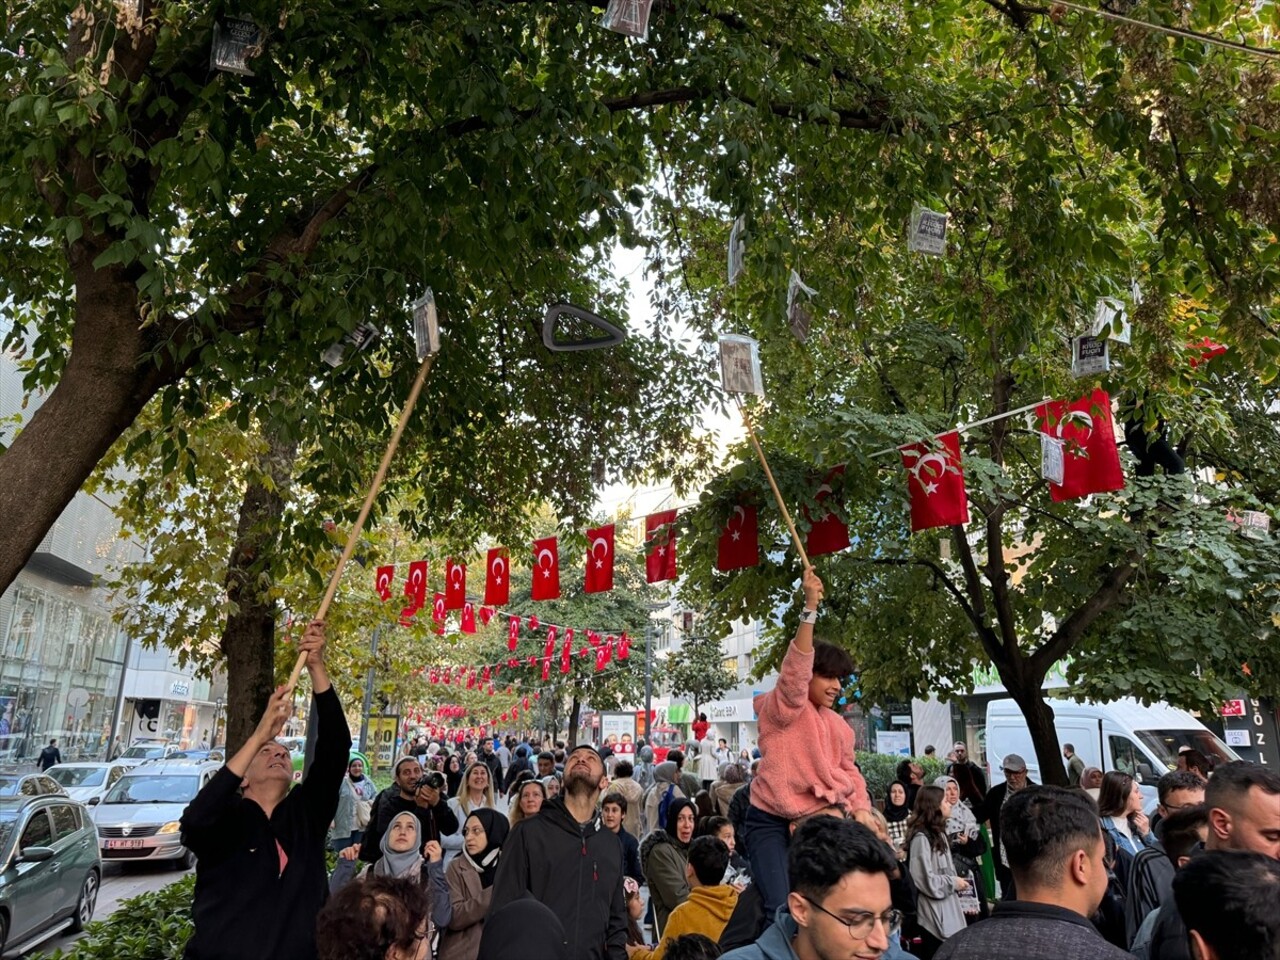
[93,760,221,869]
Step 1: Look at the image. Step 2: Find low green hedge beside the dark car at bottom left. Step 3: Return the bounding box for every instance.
[39,874,196,960]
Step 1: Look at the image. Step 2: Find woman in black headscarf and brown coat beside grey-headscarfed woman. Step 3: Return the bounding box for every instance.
[439,810,509,960]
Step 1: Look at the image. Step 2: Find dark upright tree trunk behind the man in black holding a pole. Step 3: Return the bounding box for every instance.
[221,429,297,756]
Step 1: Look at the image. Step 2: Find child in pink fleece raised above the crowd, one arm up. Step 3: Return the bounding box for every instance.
[742,567,870,922]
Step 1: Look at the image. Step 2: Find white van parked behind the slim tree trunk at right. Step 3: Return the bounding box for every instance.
[986,698,1240,814]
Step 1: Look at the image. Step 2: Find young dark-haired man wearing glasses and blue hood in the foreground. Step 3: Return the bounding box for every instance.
[721,817,908,960]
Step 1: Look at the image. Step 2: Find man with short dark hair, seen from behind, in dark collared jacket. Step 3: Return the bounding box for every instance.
[934,786,1132,960]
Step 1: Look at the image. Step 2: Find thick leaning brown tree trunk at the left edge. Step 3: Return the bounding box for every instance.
[0,266,174,593]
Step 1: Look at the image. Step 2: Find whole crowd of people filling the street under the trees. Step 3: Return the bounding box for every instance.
[172,583,1280,960]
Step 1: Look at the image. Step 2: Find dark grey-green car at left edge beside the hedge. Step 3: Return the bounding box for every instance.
[0,794,102,954]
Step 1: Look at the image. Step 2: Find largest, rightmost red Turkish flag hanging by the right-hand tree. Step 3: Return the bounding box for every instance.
[1036,388,1124,503]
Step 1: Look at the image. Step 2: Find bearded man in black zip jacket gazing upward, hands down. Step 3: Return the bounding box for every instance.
[489,744,627,960]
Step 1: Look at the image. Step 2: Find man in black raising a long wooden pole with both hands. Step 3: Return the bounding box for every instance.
[182,621,351,960]
